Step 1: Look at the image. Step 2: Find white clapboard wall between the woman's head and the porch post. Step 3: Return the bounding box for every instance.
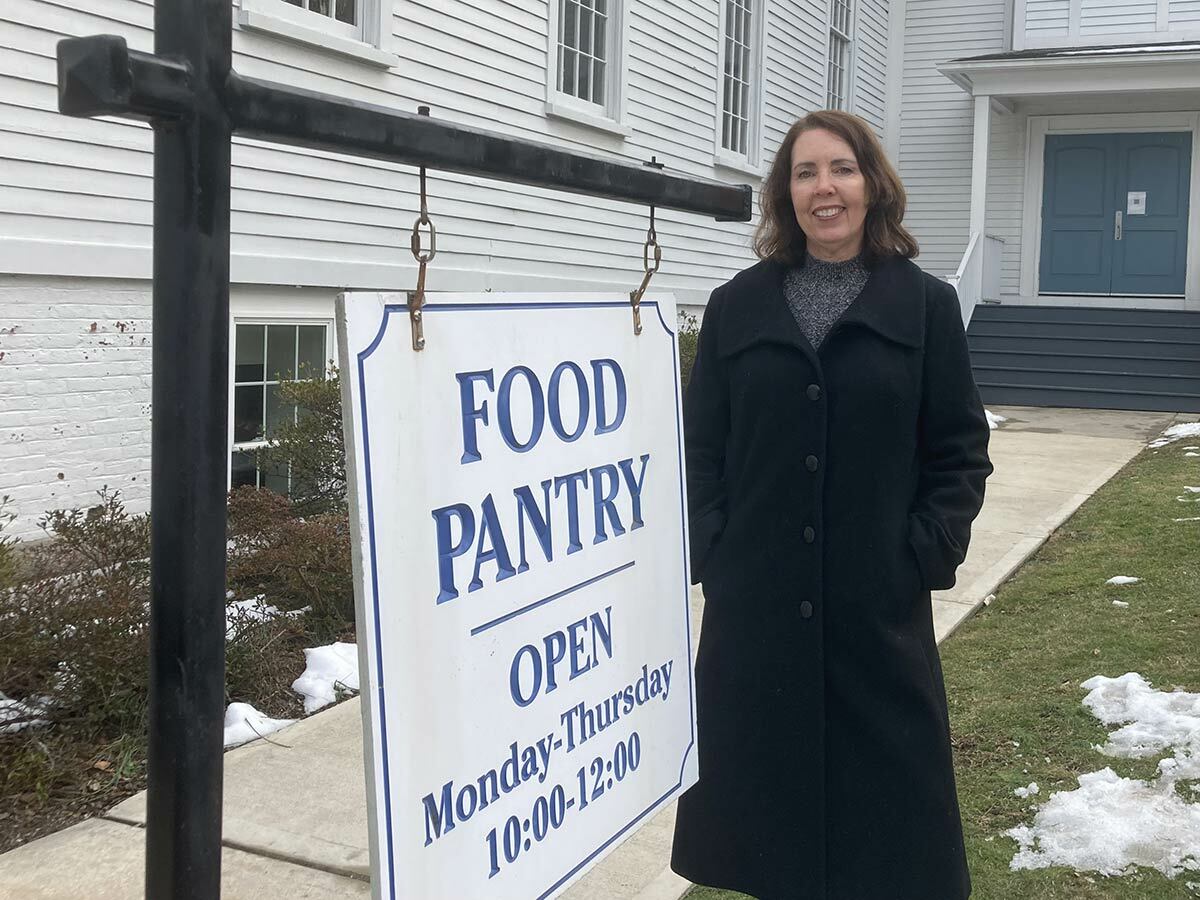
[900,0,1006,275]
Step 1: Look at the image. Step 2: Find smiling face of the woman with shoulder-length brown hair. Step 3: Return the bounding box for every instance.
[791,128,866,260]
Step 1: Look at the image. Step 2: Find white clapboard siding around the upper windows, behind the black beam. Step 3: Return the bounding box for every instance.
[0,0,854,301]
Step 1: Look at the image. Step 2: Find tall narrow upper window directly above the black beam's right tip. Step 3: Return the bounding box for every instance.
[718,0,764,163]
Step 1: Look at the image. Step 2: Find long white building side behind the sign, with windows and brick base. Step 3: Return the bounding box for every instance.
[0,0,892,536]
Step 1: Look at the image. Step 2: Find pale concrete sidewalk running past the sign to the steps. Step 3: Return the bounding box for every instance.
[0,407,1180,900]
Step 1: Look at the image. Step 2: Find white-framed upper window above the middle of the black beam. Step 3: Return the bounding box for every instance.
[546,0,631,136]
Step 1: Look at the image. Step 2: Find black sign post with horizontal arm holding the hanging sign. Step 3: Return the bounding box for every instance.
[58,0,751,900]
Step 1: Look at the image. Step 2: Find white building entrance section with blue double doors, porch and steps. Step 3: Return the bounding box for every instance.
[890,0,1200,412]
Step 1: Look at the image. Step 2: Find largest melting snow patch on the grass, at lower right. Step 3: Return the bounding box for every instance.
[1007,672,1200,877]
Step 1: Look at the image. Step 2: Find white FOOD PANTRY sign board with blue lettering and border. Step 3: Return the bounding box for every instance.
[337,293,696,900]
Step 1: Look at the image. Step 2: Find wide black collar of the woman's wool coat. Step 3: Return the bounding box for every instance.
[721,257,925,355]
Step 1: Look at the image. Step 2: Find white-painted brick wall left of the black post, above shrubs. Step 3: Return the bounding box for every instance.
[0,275,150,539]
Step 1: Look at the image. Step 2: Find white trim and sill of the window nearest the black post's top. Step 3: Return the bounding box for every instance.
[235,0,400,68]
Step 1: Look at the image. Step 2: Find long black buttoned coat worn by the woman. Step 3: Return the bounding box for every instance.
[672,258,991,900]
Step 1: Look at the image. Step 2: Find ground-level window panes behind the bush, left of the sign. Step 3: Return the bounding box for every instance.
[229,323,329,493]
